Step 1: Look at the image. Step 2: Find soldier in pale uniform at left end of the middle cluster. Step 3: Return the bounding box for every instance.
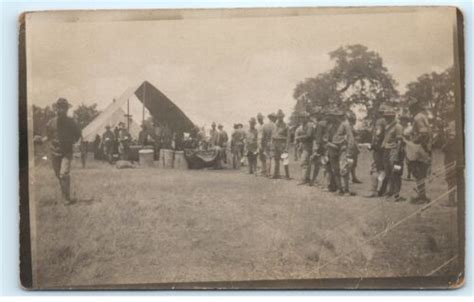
[295,111,314,185]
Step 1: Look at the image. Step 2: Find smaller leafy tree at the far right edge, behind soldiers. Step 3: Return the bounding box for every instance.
[404,67,455,121]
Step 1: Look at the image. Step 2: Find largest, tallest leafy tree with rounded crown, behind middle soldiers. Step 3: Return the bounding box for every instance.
[293,44,398,119]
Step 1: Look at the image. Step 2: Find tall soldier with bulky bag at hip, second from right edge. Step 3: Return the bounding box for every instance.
[406,98,431,204]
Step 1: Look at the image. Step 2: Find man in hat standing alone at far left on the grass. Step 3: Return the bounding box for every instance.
[46,98,81,205]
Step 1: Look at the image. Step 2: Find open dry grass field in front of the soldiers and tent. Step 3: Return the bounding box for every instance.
[31,152,458,288]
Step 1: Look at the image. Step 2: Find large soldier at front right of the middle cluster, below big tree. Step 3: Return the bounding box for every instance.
[327,109,355,195]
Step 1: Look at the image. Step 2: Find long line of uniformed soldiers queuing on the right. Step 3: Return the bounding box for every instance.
[232,99,456,205]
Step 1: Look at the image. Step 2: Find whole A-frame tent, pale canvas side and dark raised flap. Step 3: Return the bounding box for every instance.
[82,81,194,142]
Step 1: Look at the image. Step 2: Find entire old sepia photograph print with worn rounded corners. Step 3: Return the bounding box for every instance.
[19,6,465,290]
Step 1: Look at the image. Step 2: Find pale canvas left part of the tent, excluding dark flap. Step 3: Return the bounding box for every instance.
[82,87,150,142]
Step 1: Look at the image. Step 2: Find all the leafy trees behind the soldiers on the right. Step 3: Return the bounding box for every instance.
[290,44,455,124]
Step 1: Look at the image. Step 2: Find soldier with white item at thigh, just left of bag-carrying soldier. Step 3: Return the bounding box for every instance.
[382,108,405,201]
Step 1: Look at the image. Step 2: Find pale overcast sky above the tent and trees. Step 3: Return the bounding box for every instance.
[27,10,455,125]
